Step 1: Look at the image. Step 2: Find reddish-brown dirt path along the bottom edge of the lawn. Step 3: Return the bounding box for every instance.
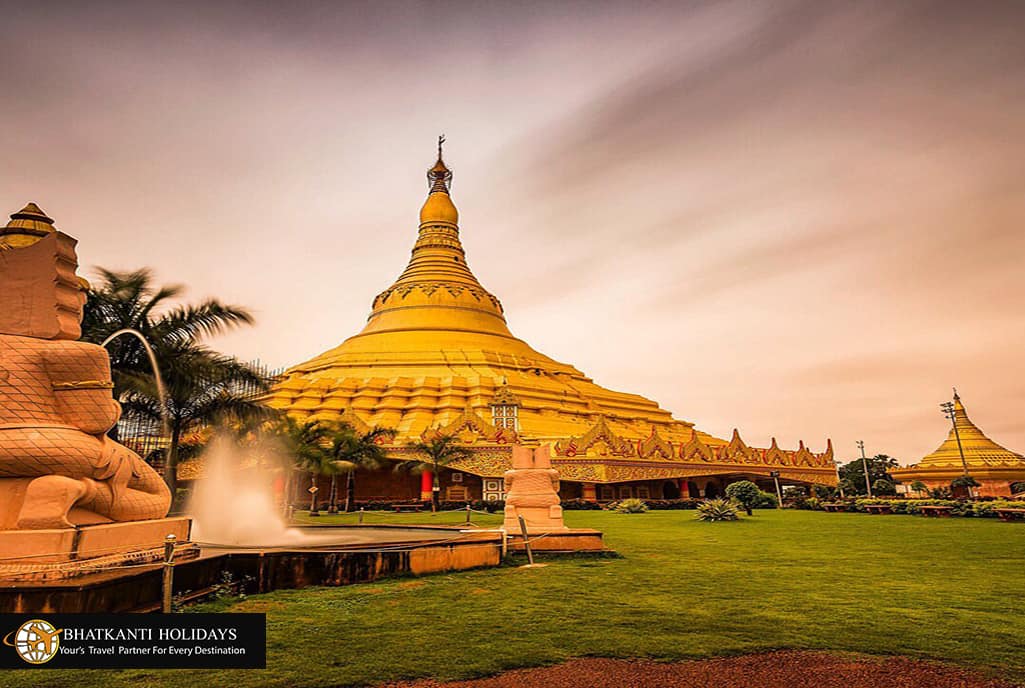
[387,651,1013,688]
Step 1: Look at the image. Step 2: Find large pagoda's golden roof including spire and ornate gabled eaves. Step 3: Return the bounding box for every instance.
[269,142,833,482]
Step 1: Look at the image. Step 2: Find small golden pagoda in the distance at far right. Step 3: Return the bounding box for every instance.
[890,390,1025,497]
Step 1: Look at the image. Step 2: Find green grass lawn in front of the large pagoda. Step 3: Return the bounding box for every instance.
[9,511,1025,688]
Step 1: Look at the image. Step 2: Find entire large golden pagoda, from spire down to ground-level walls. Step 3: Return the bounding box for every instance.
[268,139,836,500]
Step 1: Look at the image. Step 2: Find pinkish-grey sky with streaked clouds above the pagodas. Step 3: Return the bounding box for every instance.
[0,0,1025,463]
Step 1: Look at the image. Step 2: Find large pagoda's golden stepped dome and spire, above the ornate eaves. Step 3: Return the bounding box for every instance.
[268,147,692,441]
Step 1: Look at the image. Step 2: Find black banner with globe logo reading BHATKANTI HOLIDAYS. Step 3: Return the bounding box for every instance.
[0,613,267,669]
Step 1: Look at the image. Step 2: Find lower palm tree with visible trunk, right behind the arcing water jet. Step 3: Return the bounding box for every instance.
[121,341,269,494]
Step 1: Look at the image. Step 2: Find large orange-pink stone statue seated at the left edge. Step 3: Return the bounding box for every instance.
[0,204,171,530]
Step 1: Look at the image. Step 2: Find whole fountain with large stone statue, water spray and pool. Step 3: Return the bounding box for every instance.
[0,204,502,612]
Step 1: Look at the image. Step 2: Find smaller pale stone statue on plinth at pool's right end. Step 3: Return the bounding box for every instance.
[502,445,567,534]
